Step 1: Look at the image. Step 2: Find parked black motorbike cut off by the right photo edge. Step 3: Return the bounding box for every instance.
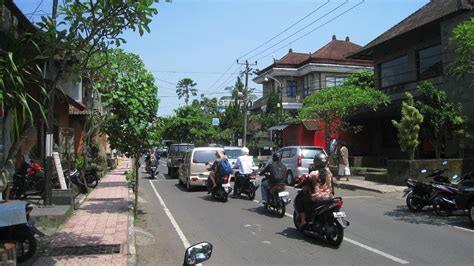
[455,173,474,226]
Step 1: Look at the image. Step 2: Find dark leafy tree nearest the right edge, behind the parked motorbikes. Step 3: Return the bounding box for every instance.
[416,81,467,159]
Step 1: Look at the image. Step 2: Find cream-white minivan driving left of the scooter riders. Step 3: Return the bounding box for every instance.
[178,147,223,191]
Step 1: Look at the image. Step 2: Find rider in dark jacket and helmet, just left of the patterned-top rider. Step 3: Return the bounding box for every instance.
[259,153,287,204]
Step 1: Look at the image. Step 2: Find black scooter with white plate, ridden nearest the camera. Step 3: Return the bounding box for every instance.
[293,190,350,247]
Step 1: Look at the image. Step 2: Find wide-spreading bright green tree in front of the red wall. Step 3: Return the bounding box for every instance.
[299,72,390,146]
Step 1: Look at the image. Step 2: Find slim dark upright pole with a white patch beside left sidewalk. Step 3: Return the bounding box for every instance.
[43,0,58,205]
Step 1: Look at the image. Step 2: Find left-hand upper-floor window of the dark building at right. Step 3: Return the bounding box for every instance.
[380,55,410,88]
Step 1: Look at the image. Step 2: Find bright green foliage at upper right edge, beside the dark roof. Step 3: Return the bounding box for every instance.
[450,17,474,78]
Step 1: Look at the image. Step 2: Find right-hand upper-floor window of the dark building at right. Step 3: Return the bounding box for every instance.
[417,44,443,79]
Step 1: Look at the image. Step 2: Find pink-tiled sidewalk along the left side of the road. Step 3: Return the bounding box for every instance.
[34,159,132,265]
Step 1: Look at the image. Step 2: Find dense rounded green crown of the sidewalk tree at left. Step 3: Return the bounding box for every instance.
[101,50,158,156]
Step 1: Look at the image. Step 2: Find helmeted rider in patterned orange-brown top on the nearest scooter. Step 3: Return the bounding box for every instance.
[295,152,334,228]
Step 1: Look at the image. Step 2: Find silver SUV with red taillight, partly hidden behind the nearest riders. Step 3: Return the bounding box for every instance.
[277,146,326,186]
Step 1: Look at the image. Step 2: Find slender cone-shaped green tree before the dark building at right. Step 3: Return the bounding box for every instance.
[392,92,423,160]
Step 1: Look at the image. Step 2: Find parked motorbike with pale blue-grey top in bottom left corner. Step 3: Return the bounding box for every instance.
[0,202,44,263]
